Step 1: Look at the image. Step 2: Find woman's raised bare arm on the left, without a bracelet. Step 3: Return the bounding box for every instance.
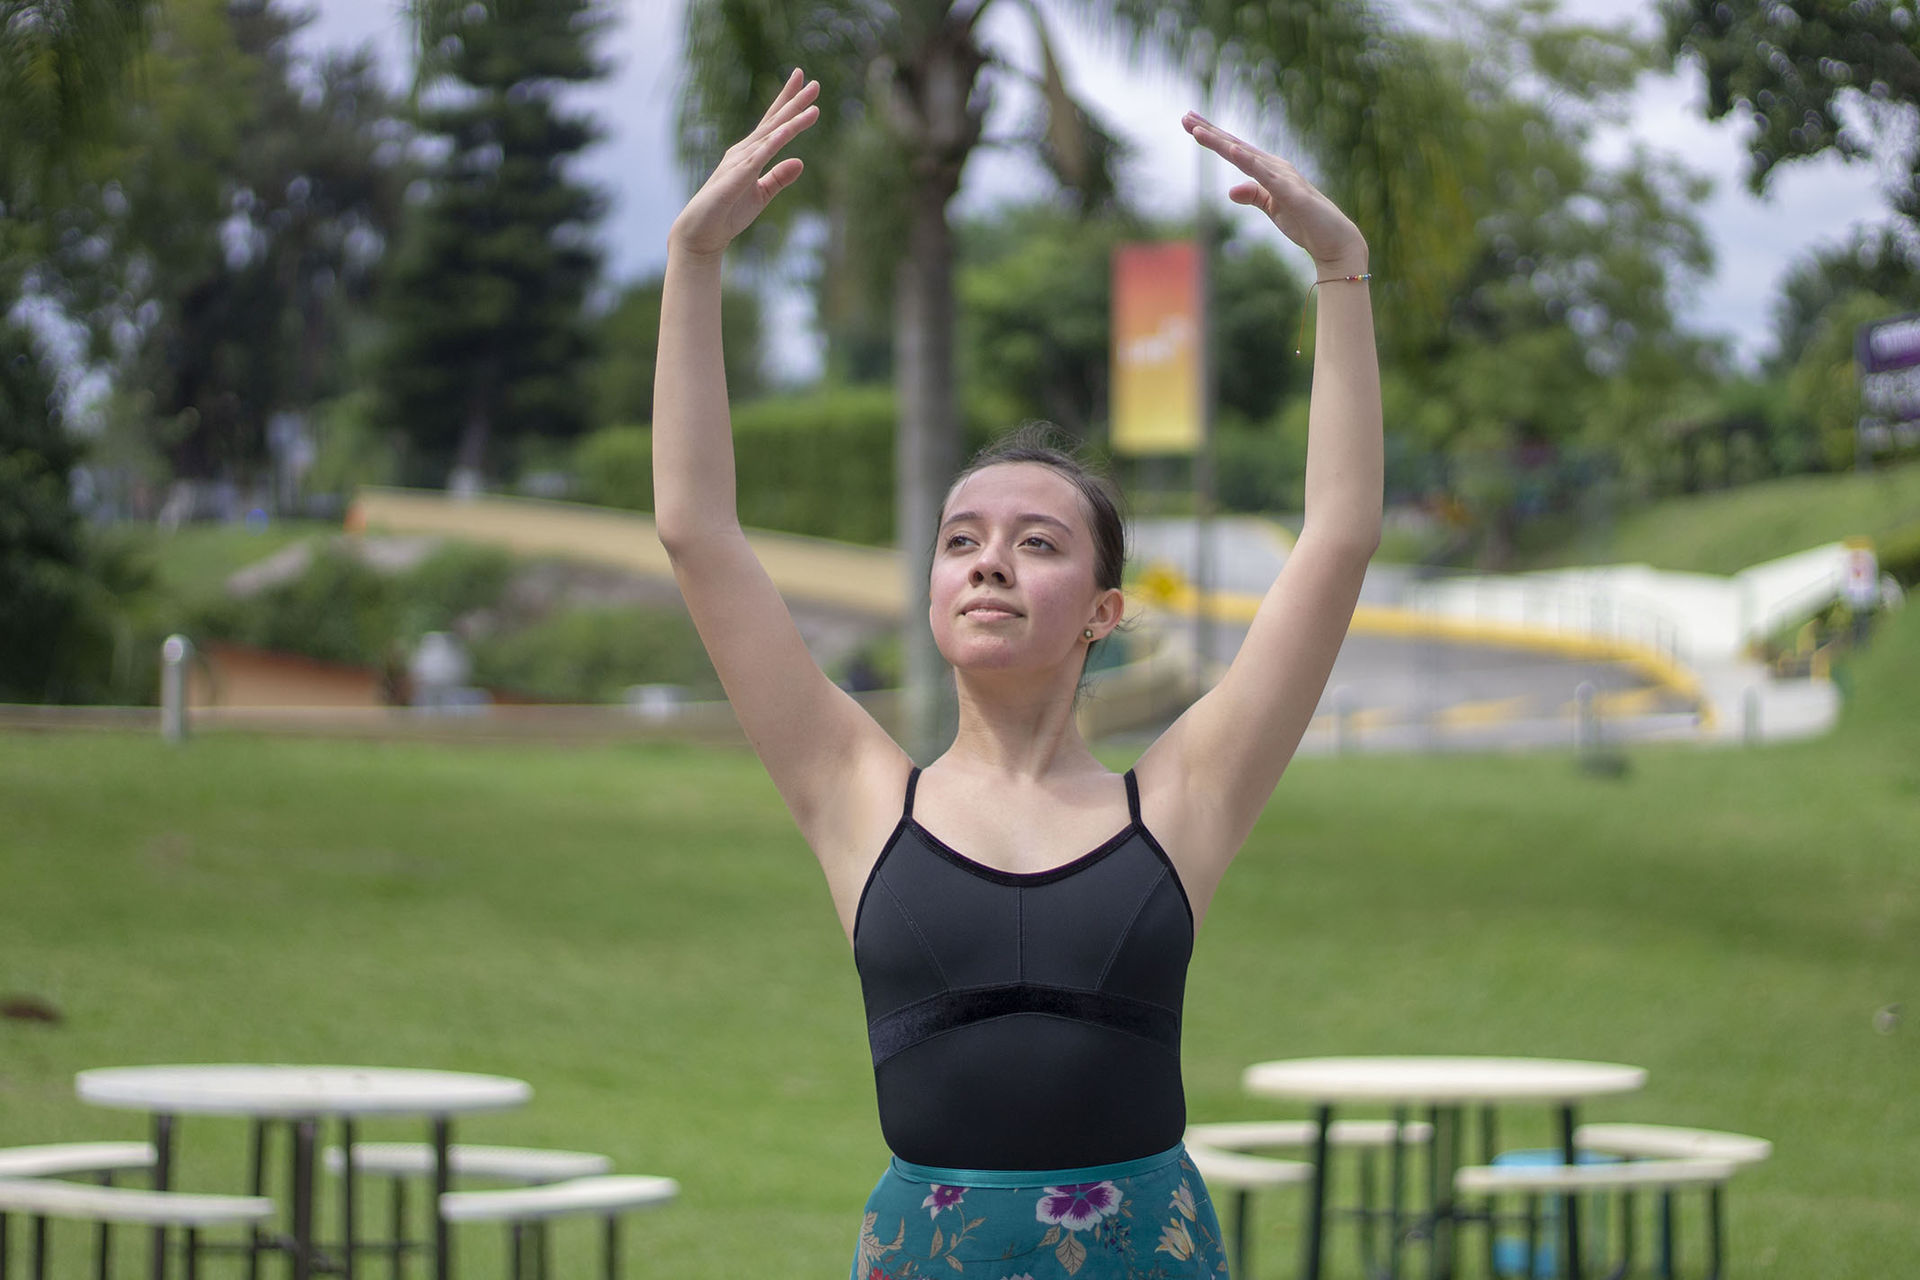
[653,71,908,909]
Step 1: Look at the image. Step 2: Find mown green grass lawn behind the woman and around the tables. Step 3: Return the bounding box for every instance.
[0,610,1920,1280]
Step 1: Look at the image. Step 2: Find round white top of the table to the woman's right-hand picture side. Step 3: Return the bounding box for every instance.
[1240,1055,1647,1103]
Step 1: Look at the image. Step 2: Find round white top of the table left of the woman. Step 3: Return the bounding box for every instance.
[73,1063,534,1119]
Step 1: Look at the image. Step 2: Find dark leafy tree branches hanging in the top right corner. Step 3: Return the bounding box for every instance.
[1661,0,1920,221]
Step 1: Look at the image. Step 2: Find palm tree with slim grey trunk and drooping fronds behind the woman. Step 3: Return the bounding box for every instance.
[680,0,1465,754]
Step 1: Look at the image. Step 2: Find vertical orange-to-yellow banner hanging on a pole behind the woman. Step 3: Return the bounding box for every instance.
[1112,240,1206,455]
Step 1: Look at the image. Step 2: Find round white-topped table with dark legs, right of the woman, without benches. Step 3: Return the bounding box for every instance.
[1240,1055,1647,1280]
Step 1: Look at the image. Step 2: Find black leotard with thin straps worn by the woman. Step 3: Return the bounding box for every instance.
[852,770,1194,1169]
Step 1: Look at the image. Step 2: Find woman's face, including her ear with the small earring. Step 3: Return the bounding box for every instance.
[927,462,1121,670]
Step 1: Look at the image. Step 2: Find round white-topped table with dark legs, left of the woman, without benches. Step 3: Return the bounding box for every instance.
[73,1063,534,1280]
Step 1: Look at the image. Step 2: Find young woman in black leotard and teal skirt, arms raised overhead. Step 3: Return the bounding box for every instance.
[653,71,1382,1280]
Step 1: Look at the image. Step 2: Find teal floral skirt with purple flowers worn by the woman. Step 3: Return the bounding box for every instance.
[851,1146,1227,1280]
